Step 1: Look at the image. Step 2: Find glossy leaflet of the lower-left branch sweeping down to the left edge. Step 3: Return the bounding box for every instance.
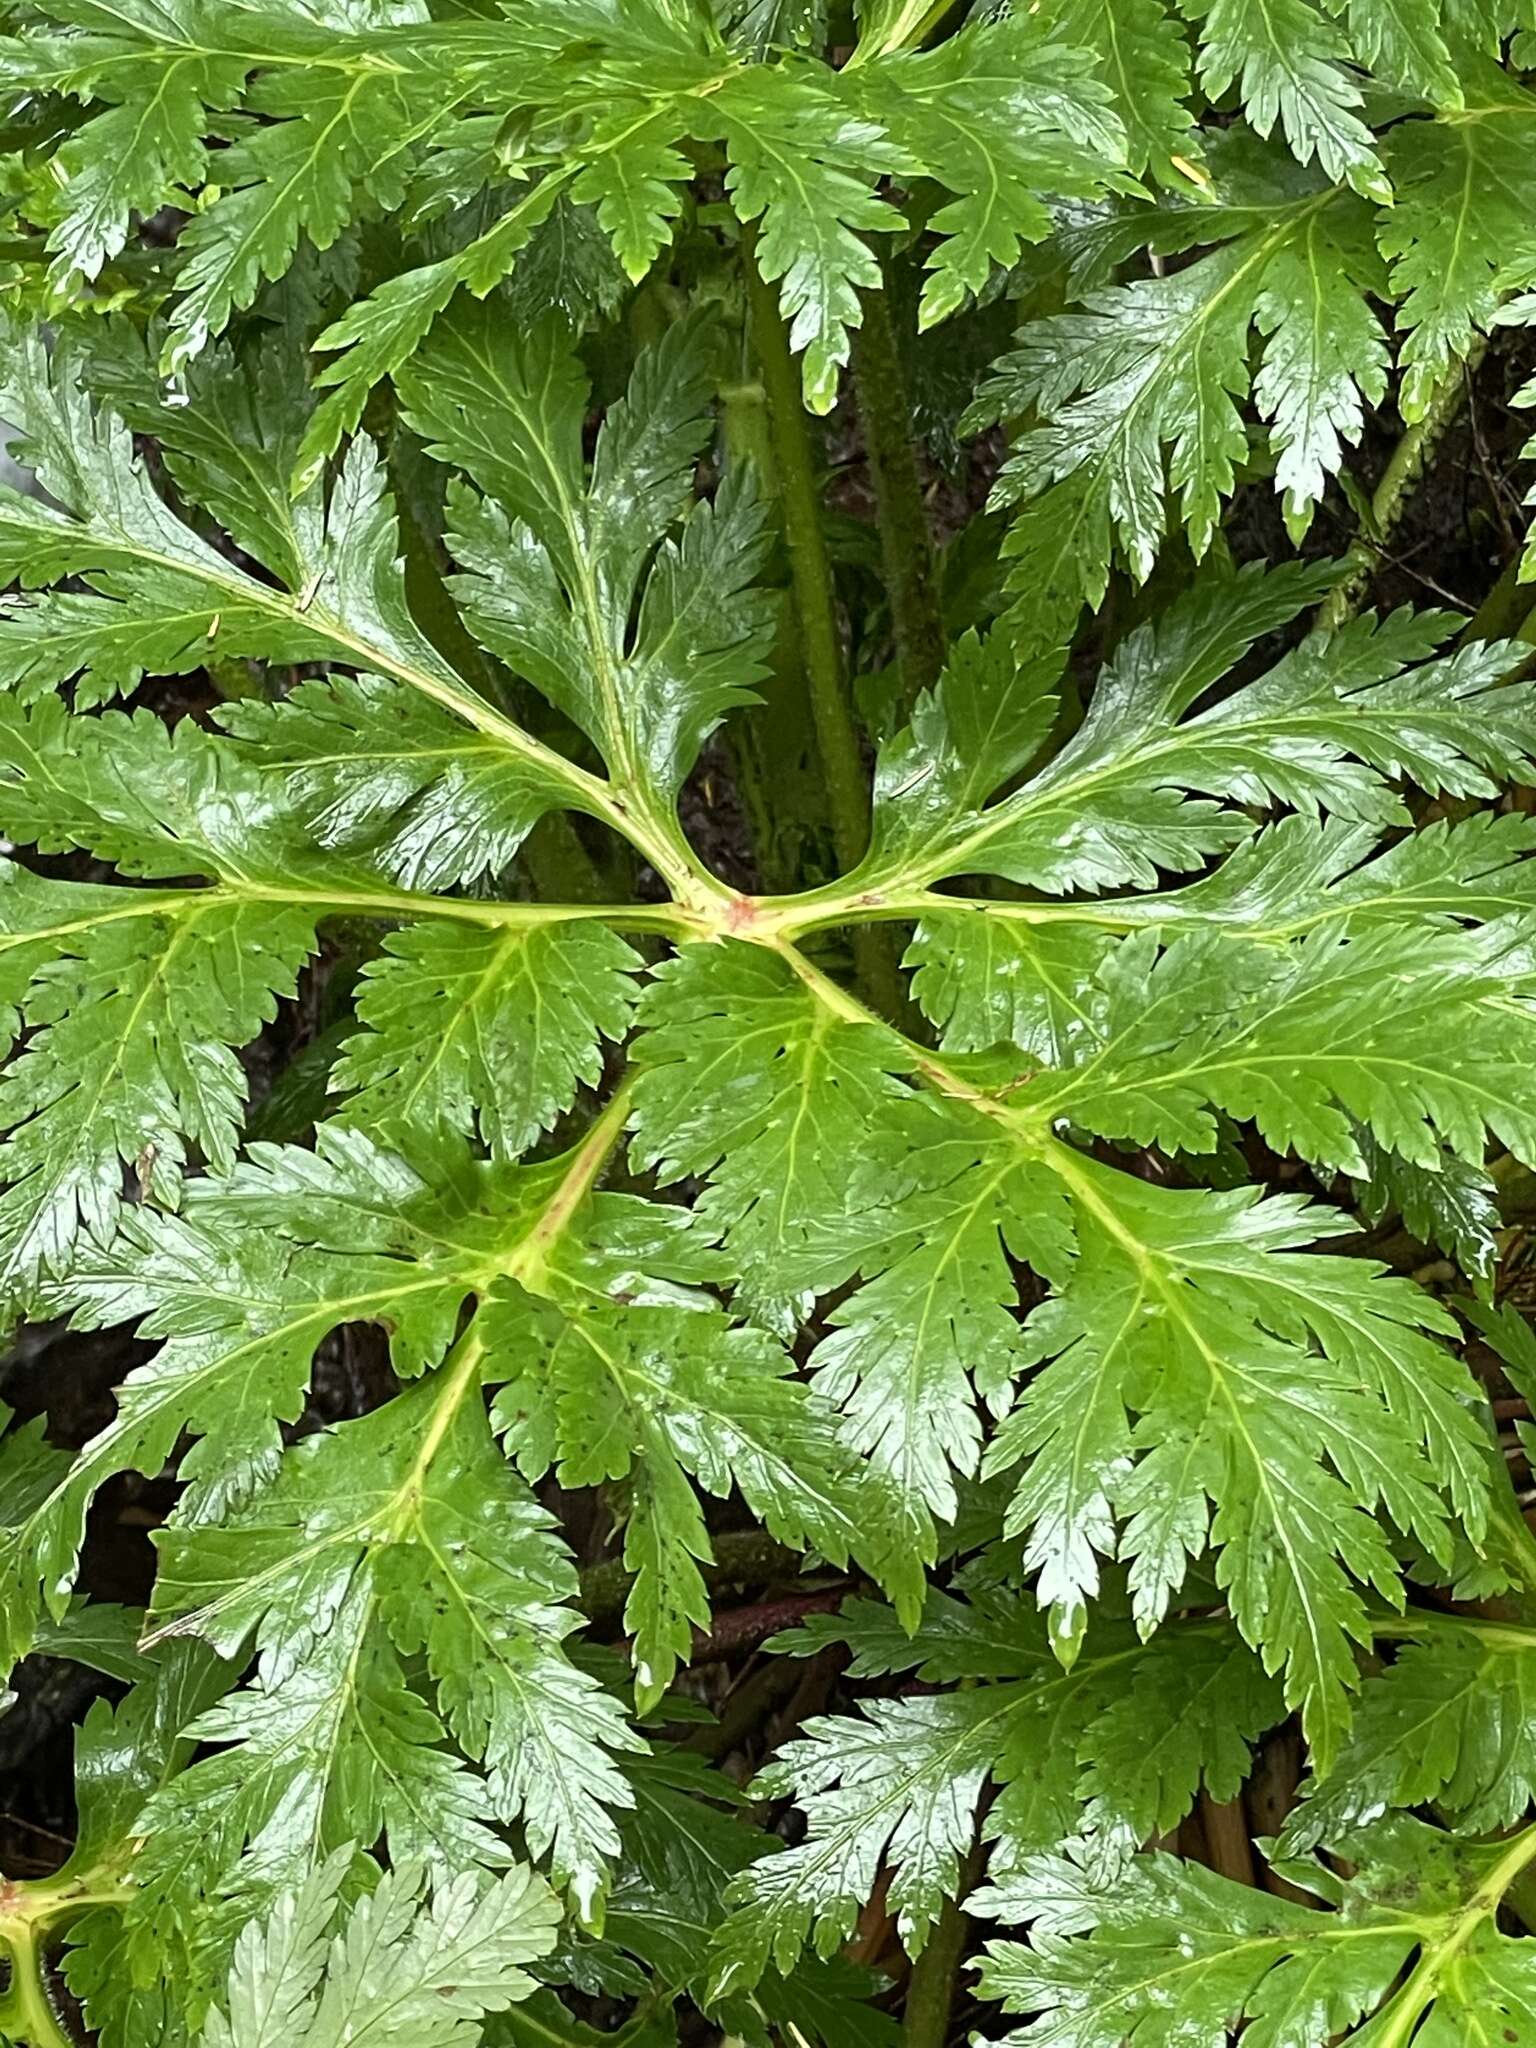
[0,1126,559,1642]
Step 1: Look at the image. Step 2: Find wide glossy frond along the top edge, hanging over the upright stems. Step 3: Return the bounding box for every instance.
[6,0,1124,419]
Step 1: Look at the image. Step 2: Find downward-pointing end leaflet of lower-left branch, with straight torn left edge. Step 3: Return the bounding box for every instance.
[145,1368,637,1913]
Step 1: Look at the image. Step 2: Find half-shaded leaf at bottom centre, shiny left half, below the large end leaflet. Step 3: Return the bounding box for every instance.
[715,1593,1282,1991]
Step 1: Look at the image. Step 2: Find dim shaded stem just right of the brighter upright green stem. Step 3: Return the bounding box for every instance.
[854,279,944,713]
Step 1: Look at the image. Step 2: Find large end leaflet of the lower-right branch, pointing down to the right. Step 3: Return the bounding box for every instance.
[985,1161,1491,1769]
